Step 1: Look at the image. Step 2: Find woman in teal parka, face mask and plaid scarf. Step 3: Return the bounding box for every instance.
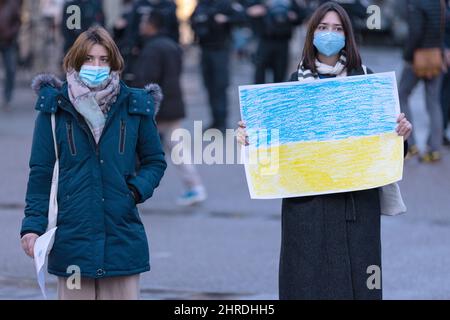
[21,27,166,299]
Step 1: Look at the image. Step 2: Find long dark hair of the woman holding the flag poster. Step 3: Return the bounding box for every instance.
[302,1,361,72]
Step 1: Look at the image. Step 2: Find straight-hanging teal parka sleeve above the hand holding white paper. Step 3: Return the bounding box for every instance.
[20,112,56,236]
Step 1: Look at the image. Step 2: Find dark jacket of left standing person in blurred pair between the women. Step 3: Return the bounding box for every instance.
[190,0,245,49]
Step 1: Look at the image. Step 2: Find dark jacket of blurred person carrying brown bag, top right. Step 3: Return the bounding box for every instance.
[403,0,445,62]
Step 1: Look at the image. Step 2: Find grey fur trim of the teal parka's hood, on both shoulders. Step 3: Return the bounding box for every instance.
[31,73,163,115]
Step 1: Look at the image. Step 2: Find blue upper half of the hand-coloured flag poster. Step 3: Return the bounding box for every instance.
[240,73,397,145]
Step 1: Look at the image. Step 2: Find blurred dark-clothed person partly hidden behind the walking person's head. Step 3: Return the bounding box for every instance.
[123,0,180,83]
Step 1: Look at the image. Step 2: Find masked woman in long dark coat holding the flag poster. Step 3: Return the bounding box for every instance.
[237,1,411,299]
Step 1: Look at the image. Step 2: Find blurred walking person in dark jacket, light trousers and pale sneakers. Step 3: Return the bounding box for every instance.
[134,11,206,205]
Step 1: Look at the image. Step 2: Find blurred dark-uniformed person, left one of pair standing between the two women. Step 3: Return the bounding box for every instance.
[190,0,245,133]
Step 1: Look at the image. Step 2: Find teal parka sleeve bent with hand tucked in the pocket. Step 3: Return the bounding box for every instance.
[127,99,167,203]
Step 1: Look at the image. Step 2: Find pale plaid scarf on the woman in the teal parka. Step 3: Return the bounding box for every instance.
[67,70,120,144]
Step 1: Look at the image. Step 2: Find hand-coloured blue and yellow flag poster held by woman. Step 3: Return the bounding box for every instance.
[239,72,403,199]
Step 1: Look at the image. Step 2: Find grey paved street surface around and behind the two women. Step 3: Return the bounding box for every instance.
[0,42,450,299]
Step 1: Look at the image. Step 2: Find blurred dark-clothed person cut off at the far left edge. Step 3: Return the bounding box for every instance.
[0,0,22,110]
